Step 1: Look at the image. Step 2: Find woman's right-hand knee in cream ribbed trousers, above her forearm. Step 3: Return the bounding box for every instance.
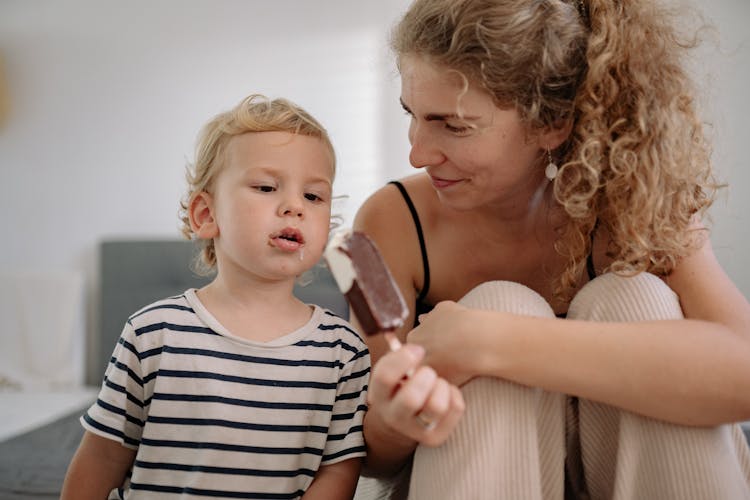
[568,273,684,321]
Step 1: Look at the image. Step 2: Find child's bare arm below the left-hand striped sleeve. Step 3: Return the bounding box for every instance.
[61,431,136,500]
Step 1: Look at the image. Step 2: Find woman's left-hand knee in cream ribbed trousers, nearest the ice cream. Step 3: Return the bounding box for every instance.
[459,281,555,317]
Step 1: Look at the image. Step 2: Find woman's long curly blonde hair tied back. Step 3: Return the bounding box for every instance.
[391,0,719,296]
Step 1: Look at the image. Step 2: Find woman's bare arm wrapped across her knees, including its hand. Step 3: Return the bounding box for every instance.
[409,234,750,426]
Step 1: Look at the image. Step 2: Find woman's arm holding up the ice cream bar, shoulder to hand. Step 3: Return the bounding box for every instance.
[350,186,464,476]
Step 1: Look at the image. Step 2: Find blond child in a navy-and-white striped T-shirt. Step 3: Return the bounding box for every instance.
[63,95,370,500]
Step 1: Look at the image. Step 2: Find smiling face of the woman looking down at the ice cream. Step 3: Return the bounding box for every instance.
[400,55,544,210]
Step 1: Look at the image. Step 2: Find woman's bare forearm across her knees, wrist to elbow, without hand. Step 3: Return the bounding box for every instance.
[473,312,750,425]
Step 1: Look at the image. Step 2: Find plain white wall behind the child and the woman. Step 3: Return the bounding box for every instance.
[0,0,750,382]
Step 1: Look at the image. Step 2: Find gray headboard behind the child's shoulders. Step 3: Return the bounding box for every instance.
[94,239,349,385]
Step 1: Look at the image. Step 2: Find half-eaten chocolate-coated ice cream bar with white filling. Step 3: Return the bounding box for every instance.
[324,230,409,342]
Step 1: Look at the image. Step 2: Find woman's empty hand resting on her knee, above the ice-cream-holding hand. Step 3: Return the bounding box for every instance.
[407,301,481,386]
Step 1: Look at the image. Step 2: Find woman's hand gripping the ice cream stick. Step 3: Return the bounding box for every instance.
[368,344,465,446]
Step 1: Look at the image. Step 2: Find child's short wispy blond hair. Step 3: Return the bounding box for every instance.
[179,94,336,274]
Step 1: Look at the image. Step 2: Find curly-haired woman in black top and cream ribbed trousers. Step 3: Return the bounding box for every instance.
[355,0,750,499]
